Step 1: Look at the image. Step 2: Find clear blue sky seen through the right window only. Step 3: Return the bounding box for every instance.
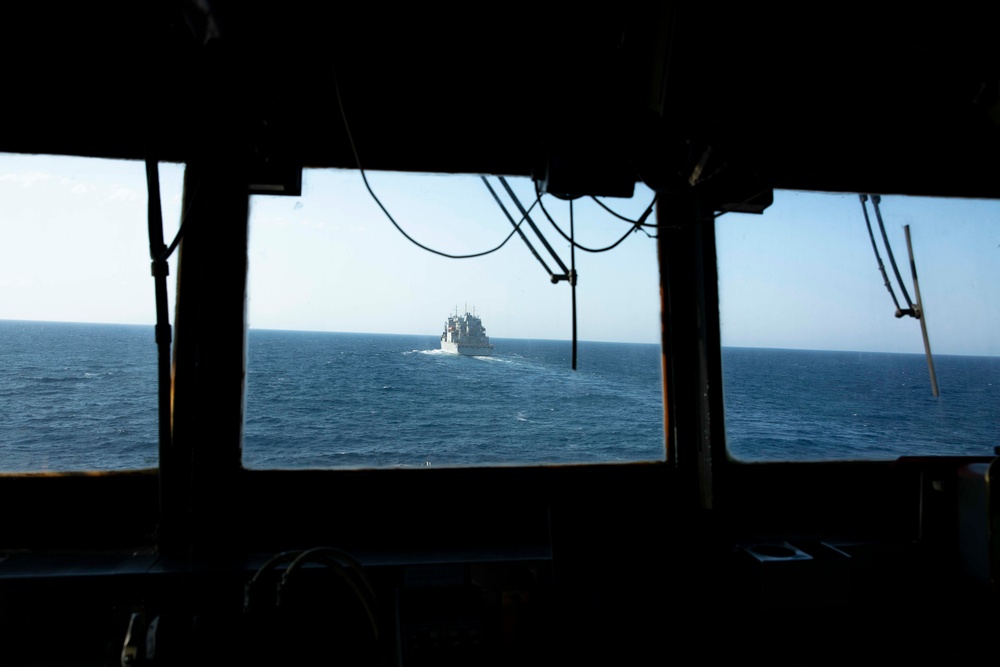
[716,192,1000,356]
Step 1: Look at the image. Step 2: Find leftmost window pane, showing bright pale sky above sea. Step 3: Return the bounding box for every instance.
[0,154,182,472]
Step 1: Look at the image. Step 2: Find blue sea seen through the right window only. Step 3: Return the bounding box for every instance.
[722,348,1000,461]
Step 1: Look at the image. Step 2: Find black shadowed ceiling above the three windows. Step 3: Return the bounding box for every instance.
[0,0,1000,197]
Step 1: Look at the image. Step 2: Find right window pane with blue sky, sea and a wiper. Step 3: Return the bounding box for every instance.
[716,192,1000,460]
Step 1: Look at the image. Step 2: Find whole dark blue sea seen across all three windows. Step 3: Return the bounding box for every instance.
[0,321,1000,472]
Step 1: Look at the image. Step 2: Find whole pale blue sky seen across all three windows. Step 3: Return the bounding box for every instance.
[0,155,1000,355]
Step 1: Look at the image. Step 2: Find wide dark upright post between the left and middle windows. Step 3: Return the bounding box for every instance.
[168,159,249,554]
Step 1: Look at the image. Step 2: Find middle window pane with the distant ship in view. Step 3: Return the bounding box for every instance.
[244,170,664,468]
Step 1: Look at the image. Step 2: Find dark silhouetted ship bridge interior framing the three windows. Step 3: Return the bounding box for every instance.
[0,0,1000,665]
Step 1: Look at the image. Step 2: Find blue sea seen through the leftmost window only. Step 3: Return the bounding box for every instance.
[0,321,158,472]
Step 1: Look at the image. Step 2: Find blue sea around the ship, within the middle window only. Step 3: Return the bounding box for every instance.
[244,331,664,468]
